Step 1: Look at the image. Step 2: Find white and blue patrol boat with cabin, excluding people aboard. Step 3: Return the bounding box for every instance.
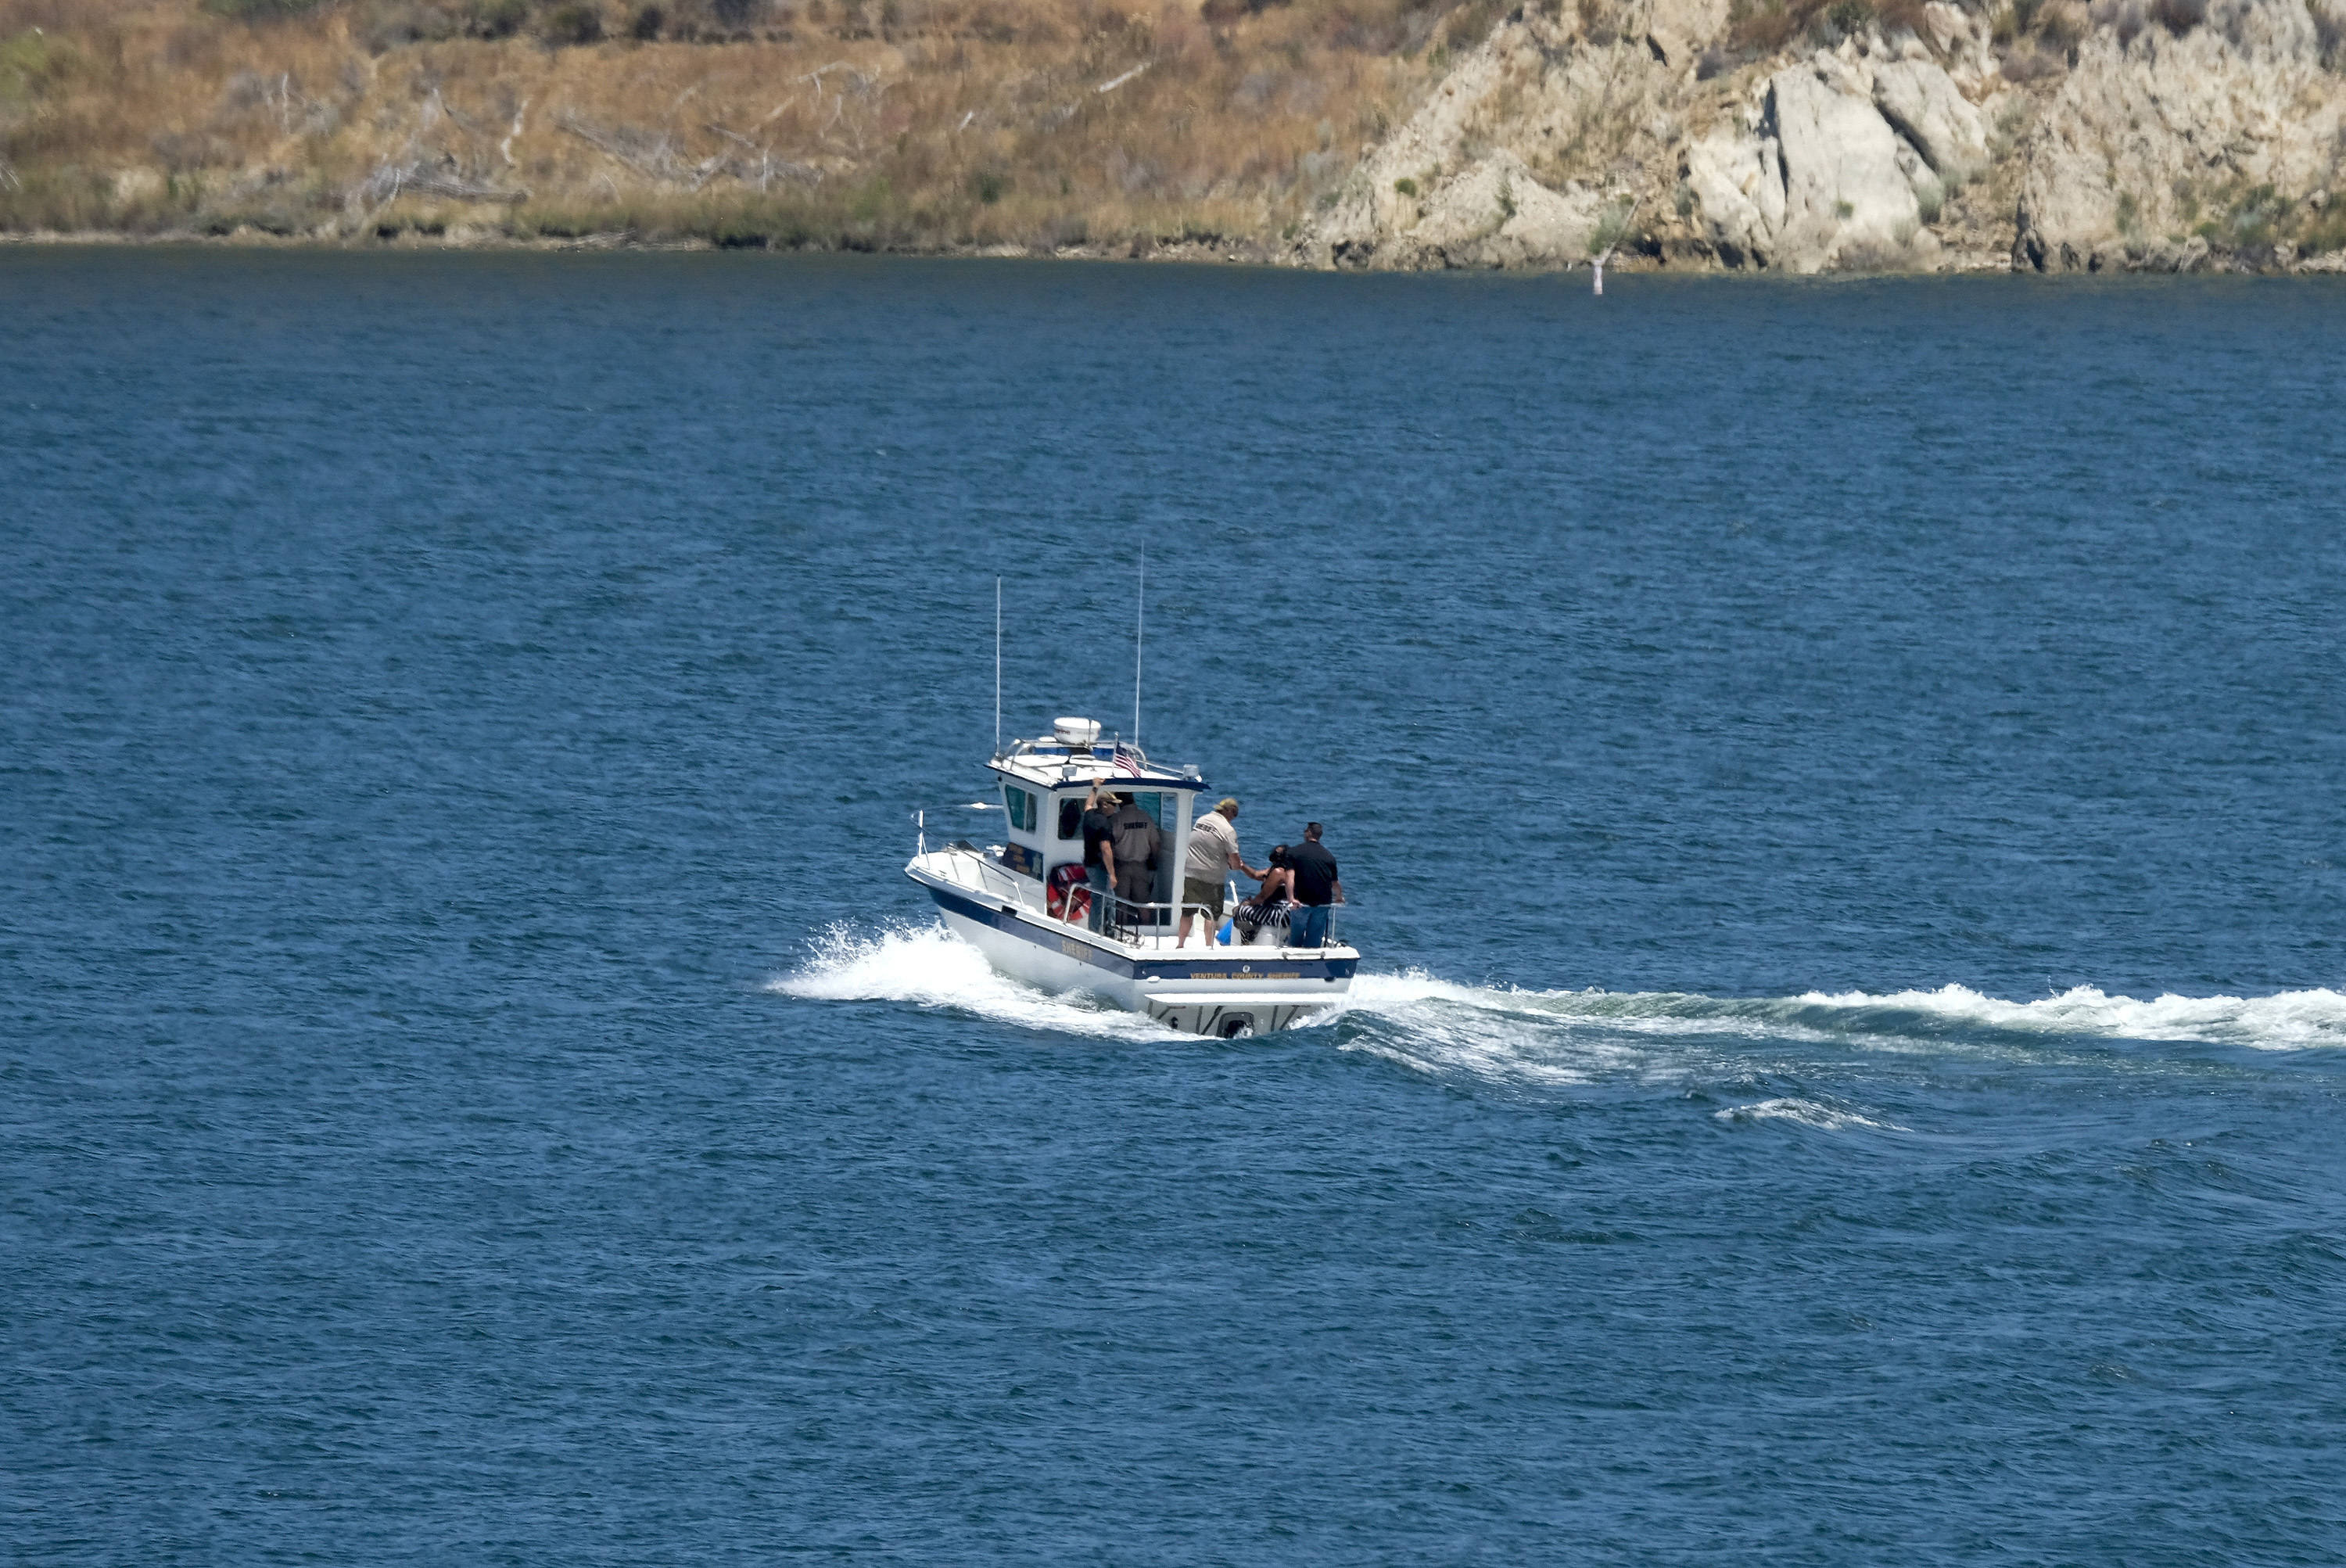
[903,718,1361,1038]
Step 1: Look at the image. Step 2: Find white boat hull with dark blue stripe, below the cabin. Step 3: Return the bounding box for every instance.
[906,850,1361,1038]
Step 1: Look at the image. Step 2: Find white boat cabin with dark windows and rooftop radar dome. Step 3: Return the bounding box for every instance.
[988,718,1206,928]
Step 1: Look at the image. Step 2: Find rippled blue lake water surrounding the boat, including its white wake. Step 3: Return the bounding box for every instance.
[0,249,2346,1568]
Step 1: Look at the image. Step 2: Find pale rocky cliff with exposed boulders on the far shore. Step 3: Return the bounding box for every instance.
[1293,0,2346,272]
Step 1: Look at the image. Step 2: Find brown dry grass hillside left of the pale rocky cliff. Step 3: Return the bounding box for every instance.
[0,0,1501,256]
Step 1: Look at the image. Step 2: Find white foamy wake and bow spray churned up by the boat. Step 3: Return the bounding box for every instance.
[767,925,2346,1070]
